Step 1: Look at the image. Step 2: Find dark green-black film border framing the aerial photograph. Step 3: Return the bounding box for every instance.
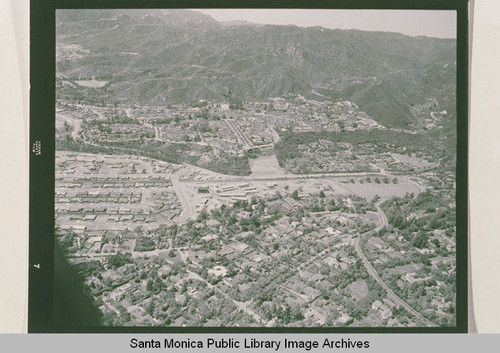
[28,0,469,333]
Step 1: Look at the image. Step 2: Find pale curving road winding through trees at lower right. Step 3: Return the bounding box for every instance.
[355,200,438,327]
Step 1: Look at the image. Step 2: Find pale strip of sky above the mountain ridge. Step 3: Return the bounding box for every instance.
[196,9,457,38]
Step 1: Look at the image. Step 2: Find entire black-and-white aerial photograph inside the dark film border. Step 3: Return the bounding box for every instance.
[55,9,457,328]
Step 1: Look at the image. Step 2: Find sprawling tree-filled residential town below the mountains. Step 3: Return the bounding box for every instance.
[55,92,456,327]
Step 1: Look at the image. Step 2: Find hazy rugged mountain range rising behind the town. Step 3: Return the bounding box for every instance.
[56,10,456,127]
